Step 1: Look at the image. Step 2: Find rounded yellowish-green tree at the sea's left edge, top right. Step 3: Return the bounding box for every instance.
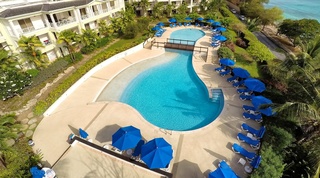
[259,7,283,29]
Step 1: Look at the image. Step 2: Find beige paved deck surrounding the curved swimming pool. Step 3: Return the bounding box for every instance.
[33,26,259,178]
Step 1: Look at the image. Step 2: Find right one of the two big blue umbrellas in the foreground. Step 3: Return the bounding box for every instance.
[141,138,173,169]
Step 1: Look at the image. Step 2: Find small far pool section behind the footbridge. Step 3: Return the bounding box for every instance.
[170,28,205,45]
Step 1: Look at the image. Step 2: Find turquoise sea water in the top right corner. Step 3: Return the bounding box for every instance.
[265,0,320,22]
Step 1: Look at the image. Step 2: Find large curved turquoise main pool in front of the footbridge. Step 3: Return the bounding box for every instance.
[119,50,224,131]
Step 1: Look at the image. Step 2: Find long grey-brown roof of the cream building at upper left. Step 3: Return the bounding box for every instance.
[0,0,93,18]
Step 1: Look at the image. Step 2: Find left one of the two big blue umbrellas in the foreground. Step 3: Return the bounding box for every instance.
[112,126,142,151]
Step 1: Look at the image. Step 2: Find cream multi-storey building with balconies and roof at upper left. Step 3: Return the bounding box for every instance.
[0,0,125,61]
